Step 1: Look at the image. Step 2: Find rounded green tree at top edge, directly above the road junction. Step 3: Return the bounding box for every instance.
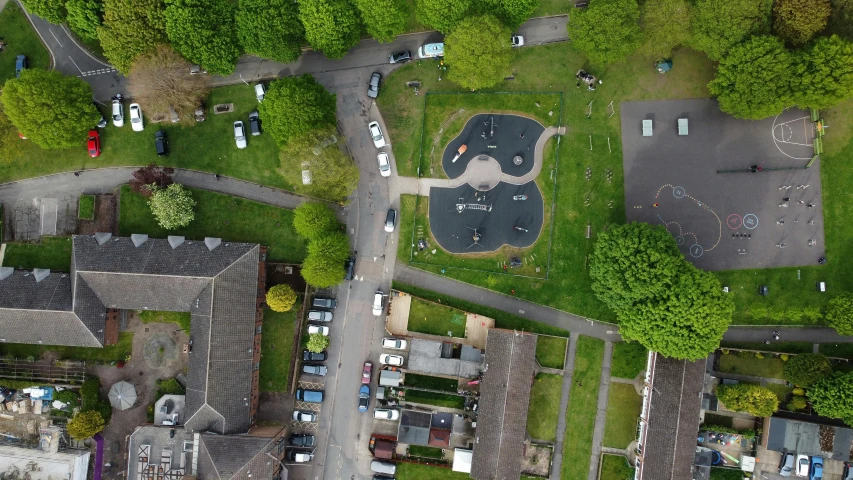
[298,0,361,59]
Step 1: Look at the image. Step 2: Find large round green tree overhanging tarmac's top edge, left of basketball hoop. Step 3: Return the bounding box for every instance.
[708,35,793,120]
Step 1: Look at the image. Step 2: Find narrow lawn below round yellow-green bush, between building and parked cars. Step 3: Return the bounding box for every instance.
[259,301,298,392]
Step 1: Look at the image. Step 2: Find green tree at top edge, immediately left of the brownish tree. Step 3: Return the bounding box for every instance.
[690,0,773,60]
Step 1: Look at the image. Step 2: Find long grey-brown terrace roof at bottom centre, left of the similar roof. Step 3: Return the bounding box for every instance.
[471,328,536,480]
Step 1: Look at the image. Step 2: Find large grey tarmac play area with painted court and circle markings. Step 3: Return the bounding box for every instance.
[620,99,825,270]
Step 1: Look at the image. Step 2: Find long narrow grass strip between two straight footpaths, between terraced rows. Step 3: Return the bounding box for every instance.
[560,335,604,480]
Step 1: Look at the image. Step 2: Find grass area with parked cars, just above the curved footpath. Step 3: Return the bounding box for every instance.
[0,84,291,190]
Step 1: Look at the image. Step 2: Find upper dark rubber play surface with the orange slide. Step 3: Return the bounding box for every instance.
[442,113,545,178]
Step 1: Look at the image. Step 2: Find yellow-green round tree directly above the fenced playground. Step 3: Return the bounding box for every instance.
[444,15,512,90]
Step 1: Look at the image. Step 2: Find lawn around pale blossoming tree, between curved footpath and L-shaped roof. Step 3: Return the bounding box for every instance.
[118,185,306,263]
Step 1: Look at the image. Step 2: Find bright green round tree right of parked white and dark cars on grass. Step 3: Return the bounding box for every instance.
[258,73,336,146]
